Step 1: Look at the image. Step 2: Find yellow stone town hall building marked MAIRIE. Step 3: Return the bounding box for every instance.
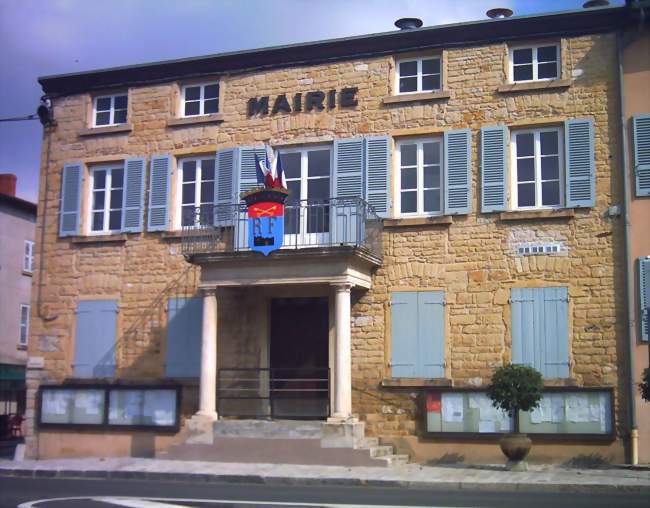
[27,6,635,461]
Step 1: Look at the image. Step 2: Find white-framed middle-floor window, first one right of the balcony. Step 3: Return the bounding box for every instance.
[397,139,442,215]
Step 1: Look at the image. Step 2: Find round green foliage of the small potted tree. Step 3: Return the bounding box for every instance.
[487,365,544,416]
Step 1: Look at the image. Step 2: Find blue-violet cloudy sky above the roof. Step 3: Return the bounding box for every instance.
[0,0,623,201]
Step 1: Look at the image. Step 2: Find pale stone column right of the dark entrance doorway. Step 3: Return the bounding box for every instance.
[333,284,352,420]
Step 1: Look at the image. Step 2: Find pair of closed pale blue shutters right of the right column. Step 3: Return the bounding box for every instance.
[390,291,445,378]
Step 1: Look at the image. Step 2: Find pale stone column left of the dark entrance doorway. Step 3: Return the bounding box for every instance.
[197,288,217,420]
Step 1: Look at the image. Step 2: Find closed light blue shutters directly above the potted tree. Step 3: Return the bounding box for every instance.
[510,287,569,378]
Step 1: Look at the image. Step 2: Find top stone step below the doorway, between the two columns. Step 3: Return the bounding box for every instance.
[213,420,322,439]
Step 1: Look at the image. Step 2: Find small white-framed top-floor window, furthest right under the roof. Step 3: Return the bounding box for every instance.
[510,44,560,83]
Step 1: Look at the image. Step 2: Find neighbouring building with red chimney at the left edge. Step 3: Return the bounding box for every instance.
[0,173,36,439]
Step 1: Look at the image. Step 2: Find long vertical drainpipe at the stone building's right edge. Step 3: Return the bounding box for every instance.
[616,31,639,465]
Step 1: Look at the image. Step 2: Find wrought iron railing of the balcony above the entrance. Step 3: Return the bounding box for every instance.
[182,194,382,258]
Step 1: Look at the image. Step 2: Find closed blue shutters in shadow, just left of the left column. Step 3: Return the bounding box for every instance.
[165,298,203,378]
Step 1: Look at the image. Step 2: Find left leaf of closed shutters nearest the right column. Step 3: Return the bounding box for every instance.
[390,291,418,378]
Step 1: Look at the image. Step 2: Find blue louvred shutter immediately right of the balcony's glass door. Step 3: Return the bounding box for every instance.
[330,138,364,244]
